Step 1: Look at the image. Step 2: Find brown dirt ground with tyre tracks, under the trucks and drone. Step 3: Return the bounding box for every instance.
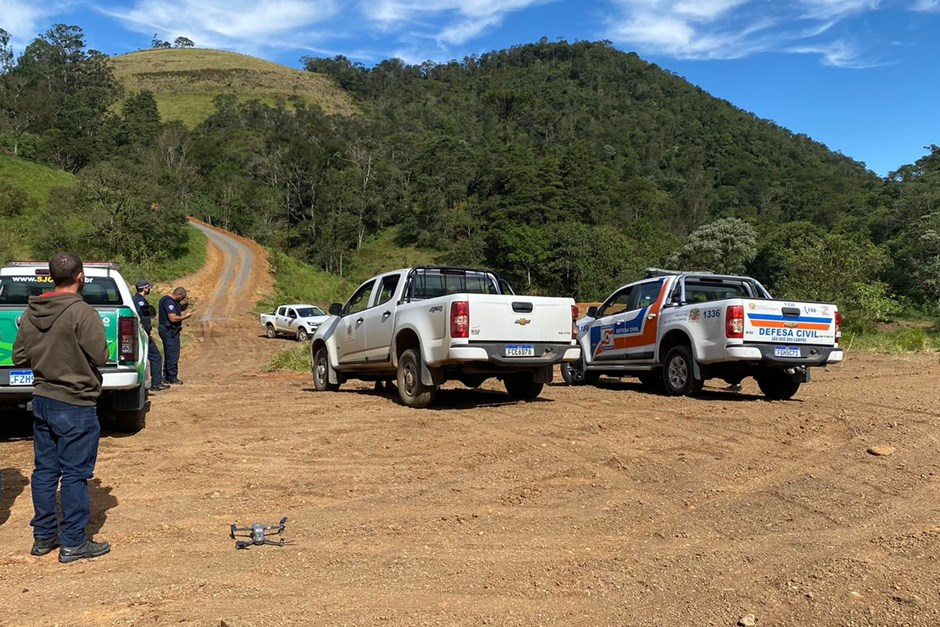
[0,226,940,627]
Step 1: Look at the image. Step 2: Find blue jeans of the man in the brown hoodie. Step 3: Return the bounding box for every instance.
[30,396,101,546]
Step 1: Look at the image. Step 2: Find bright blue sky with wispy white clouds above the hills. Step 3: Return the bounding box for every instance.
[0,0,940,176]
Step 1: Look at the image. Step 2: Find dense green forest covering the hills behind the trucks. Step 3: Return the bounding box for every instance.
[0,25,940,328]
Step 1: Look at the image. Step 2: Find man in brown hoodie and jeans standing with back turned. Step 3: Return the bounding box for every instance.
[13,253,111,563]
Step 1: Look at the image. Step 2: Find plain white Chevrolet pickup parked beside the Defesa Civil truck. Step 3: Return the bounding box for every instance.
[310,266,580,407]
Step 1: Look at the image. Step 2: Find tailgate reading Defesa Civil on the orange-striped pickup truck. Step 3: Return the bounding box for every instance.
[743,300,837,346]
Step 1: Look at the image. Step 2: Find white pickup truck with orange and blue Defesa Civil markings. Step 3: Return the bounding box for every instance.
[562,269,844,400]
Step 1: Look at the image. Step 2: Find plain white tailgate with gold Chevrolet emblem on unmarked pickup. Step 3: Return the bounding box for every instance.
[467,294,574,342]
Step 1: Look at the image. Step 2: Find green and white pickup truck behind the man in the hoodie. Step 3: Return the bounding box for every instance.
[0,261,150,431]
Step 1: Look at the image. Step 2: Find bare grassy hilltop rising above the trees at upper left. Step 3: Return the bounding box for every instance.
[111,48,356,127]
